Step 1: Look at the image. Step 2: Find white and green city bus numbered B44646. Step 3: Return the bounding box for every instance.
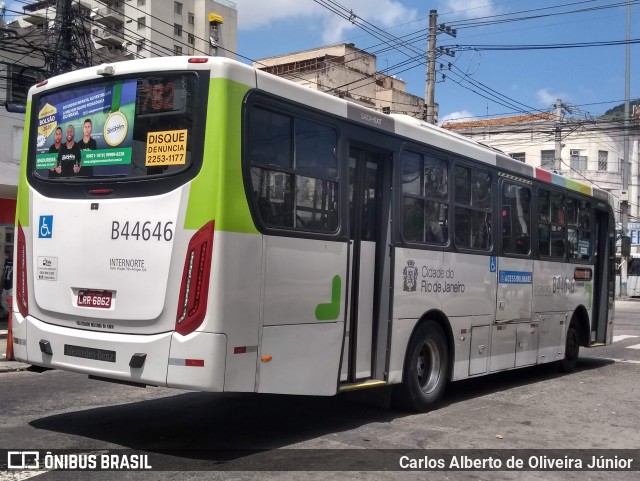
[13,57,615,410]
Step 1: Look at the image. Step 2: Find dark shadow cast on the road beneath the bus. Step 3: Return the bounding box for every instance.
[30,358,612,460]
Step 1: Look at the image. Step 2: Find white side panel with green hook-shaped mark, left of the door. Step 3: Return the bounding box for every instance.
[258,236,348,395]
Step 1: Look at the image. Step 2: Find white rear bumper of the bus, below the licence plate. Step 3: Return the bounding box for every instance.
[13,312,226,391]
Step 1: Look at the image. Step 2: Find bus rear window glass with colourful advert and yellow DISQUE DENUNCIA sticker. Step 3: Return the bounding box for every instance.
[31,73,198,182]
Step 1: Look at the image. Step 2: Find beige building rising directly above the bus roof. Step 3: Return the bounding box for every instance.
[253,44,424,117]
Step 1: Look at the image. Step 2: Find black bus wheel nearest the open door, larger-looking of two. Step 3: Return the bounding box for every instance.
[394,321,449,412]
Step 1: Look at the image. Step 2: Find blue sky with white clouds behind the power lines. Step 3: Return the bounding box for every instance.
[236,0,640,123]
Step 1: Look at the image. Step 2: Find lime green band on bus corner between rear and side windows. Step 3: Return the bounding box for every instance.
[184,78,258,234]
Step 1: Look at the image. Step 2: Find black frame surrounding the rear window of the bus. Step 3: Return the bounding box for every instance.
[26,70,210,199]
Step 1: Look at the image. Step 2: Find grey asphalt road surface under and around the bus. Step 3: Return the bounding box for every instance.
[0,302,640,481]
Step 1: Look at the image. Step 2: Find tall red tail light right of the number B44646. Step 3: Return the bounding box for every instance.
[176,221,214,336]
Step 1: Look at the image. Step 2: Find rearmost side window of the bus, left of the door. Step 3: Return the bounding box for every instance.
[248,107,339,233]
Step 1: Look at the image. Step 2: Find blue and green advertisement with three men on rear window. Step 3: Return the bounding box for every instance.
[36,80,136,178]
